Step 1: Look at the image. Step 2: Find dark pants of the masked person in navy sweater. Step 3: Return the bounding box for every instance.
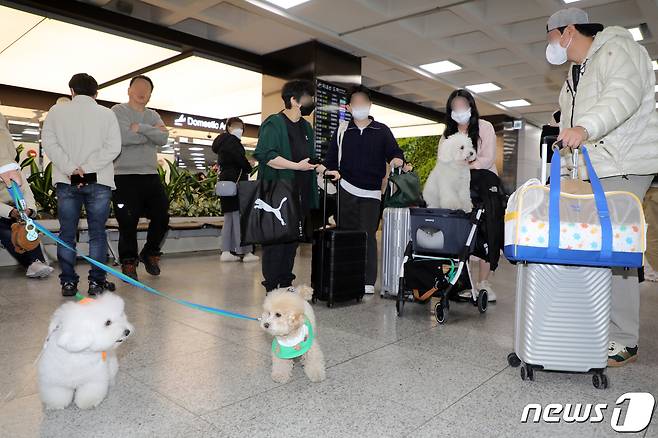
[339,188,381,286]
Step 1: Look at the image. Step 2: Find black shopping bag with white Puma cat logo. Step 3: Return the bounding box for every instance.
[238,180,304,246]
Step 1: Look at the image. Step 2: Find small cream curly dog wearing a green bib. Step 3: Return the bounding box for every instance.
[260,286,326,383]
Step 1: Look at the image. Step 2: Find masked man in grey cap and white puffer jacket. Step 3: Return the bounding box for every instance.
[546,8,658,366]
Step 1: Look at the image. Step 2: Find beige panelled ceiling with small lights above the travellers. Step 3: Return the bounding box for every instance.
[60,0,658,125]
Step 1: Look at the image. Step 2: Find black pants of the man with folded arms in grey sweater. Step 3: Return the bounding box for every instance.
[112,175,169,262]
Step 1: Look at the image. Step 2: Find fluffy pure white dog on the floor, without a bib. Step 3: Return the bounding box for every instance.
[39,292,134,409]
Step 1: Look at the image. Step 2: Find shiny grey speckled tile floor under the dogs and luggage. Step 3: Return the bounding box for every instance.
[0,247,658,438]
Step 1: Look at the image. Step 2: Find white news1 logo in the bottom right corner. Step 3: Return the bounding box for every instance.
[521,392,656,433]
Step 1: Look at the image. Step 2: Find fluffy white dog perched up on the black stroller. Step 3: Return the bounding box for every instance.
[423,133,476,213]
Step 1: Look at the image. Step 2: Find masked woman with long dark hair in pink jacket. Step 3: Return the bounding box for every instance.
[443,89,498,302]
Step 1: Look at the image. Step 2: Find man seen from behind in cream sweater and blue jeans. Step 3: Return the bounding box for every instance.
[41,73,121,297]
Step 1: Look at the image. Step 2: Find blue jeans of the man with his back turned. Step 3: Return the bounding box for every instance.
[57,183,112,284]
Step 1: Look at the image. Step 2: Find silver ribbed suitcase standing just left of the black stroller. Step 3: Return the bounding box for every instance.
[380,208,404,298]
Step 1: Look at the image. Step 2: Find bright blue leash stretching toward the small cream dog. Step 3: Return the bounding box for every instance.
[9,181,258,321]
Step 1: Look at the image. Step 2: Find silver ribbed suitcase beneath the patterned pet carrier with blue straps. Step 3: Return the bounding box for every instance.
[514,264,612,374]
